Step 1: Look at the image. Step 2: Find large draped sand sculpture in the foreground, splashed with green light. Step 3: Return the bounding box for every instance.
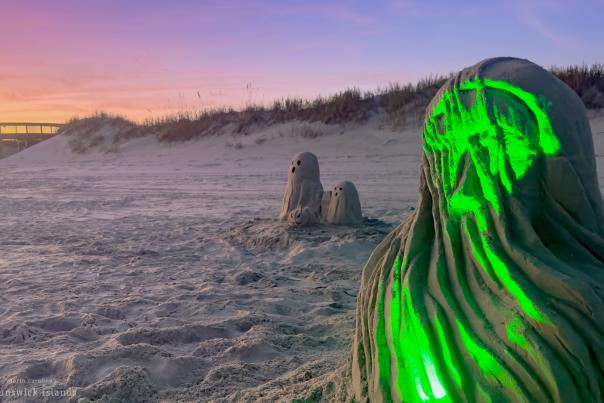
[348,58,604,402]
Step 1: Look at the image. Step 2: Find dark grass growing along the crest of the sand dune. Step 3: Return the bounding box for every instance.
[66,64,604,141]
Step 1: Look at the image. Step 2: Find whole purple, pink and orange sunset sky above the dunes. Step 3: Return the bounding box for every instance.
[0,0,604,122]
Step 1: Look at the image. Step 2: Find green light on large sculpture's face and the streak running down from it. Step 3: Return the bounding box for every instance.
[424,79,560,322]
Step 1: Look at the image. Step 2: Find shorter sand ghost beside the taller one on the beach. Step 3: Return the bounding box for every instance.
[322,181,363,225]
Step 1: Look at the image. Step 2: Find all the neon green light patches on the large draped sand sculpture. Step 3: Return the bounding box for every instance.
[390,78,560,402]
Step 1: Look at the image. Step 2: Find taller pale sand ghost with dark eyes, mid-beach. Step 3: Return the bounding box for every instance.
[279,152,323,225]
